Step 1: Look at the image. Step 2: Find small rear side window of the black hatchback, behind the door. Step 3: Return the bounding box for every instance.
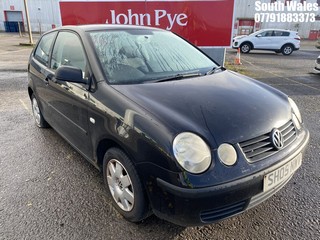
[34,32,56,66]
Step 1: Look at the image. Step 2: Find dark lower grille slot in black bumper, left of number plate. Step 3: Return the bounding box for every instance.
[200,201,248,223]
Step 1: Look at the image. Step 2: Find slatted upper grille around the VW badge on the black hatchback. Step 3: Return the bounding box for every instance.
[239,120,297,162]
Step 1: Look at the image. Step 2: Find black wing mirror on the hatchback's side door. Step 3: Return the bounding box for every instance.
[55,66,88,84]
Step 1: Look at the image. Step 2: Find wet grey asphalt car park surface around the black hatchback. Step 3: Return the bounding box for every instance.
[0,33,320,240]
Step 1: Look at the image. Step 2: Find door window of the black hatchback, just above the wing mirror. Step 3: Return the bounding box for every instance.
[50,32,87,76]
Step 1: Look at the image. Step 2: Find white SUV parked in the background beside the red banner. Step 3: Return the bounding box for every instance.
[232,29,300,55]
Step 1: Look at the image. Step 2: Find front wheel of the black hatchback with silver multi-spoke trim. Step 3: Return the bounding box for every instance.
[103,148,148,222]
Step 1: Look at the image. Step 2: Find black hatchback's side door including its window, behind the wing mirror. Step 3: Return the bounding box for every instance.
[47,31,92,157]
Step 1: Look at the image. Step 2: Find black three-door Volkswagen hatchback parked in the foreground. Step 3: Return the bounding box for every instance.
[28,25,309,226]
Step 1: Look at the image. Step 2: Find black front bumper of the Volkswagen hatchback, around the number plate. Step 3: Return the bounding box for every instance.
[151,128,309,226]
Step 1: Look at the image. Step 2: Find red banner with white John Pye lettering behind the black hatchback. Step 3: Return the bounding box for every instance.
[60,0,234,47]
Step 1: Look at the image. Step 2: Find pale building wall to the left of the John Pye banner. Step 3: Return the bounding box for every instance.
[0,0,61,32]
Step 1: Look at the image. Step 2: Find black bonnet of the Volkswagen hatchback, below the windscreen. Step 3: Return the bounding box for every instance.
[113,71,291,144]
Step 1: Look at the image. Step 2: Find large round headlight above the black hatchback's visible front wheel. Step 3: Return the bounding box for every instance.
[173,132,211,173]
